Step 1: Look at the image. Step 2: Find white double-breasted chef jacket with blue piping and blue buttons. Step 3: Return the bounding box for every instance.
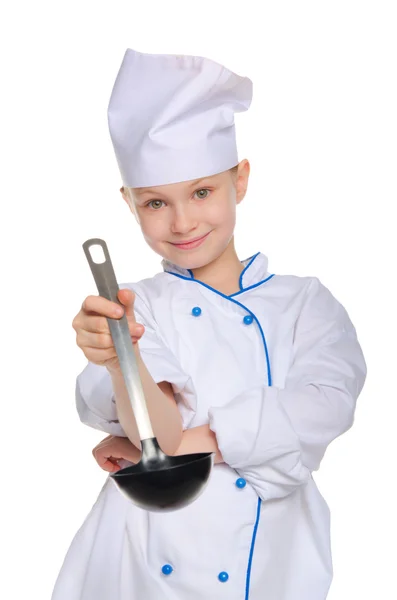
[52,252,366,600]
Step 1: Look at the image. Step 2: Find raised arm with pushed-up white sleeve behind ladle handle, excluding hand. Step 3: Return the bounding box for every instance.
[76,289,190,454]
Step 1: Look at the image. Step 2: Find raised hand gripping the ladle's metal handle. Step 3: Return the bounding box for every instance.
[72,289,145,369]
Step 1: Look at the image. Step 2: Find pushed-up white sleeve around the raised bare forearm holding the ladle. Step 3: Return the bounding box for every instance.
[76,285,194,437]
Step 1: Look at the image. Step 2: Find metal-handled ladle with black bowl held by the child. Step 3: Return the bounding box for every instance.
[83,238,214,512]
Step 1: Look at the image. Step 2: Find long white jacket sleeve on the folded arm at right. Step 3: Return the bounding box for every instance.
[209,278,366,500]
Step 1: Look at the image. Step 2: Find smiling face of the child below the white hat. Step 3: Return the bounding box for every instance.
[122,160,250,269]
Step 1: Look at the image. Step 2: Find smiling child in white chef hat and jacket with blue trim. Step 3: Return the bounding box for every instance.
[52,50,366,600]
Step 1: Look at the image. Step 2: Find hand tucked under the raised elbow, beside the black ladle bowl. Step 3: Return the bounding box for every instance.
[92,435,141,473]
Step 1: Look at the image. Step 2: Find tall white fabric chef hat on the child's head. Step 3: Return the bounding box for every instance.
[108,49,252,187]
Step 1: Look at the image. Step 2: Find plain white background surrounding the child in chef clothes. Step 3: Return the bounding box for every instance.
[0,0,397,600]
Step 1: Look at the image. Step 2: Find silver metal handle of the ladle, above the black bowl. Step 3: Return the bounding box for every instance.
[83,238,154,440]
